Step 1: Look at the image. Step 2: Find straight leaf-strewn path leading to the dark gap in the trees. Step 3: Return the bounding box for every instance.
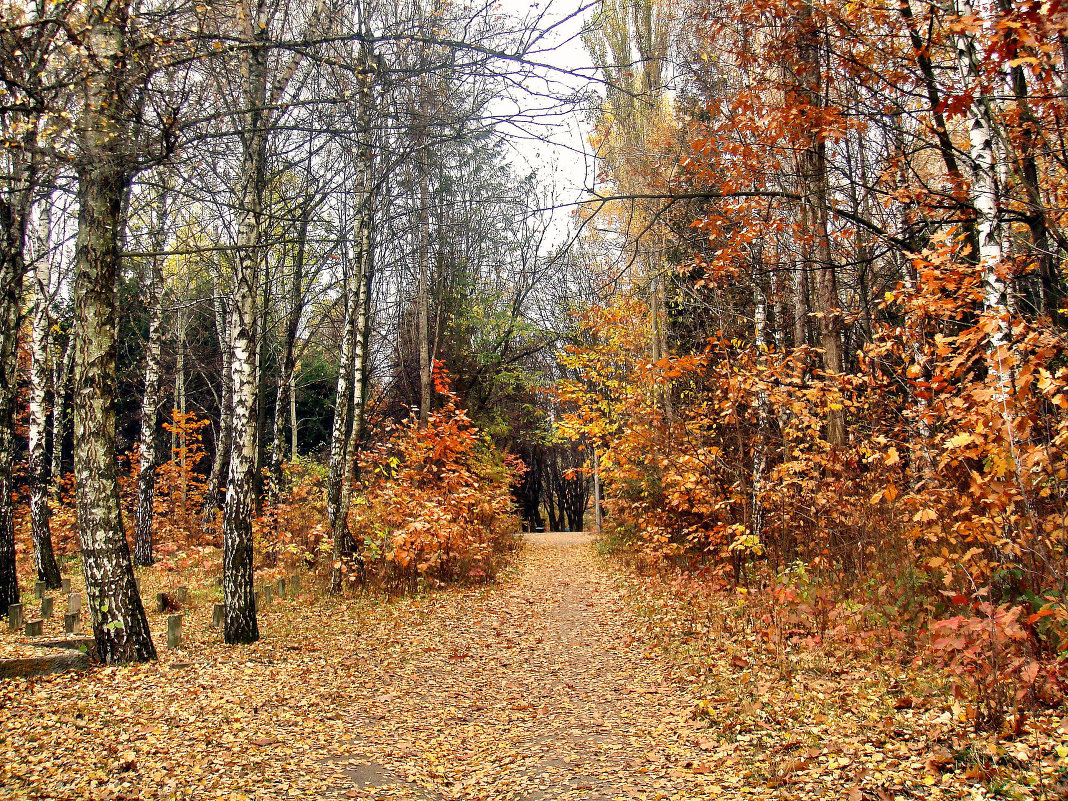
[316,534,701,801]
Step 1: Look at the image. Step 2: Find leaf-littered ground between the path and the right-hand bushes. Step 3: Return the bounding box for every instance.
[601,540,1068,801]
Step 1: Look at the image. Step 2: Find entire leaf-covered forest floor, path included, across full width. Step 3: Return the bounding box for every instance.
[0,535,1068,801]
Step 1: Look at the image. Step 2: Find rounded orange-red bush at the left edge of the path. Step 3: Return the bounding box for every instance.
[349,371,522,588]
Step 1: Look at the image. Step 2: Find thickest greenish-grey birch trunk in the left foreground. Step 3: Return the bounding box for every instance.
[73,9,156,663]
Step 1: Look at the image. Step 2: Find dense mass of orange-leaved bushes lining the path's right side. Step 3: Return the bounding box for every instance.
[557,290,1068,725]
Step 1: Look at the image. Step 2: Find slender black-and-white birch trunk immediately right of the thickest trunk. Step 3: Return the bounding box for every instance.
[134,220,167,565]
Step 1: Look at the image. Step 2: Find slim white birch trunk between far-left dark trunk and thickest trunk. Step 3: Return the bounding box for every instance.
[29,195,60,590]
